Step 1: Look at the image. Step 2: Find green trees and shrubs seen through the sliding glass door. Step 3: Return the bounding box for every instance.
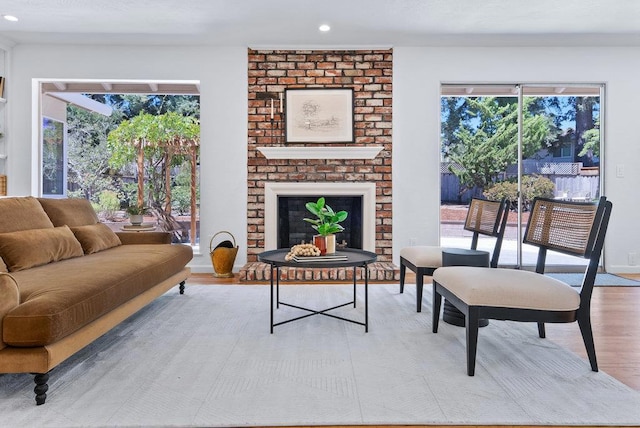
[441,96,600,205]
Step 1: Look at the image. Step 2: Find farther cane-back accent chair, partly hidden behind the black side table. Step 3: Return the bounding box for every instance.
[400,198,509,312]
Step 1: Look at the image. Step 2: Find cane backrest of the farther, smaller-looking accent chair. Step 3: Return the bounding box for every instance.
[464,198,509,267]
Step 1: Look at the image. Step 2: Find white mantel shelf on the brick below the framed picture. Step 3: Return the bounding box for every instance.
[257,146,384,159]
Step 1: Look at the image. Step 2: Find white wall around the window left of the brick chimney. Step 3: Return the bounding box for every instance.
[7,45,247,272]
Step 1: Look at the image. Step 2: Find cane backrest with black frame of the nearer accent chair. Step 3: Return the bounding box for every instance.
[523,196,613,300]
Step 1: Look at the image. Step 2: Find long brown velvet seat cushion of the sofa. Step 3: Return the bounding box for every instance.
[2,244,193,347]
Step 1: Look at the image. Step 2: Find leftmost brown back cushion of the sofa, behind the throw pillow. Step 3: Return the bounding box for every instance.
[0,196,53,233]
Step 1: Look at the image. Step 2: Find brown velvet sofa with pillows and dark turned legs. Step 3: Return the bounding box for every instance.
[0,197,193,404]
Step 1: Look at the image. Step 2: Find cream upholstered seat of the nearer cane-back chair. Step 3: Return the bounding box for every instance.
[433,266,580,311]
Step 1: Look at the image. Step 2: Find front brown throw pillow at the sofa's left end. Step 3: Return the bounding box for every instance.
[0,226,84,272]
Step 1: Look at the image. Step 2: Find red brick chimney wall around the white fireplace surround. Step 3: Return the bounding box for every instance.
[247,49,393,262]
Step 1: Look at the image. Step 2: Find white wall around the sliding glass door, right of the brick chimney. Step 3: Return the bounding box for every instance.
[393,47,640,273]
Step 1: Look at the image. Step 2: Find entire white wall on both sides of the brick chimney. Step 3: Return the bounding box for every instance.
[8,45,640,273]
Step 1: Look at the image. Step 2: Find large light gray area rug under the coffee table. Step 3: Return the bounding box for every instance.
[0,284,640,427]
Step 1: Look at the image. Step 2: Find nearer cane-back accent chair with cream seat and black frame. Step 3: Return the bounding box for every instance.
[432,196,612,376]
